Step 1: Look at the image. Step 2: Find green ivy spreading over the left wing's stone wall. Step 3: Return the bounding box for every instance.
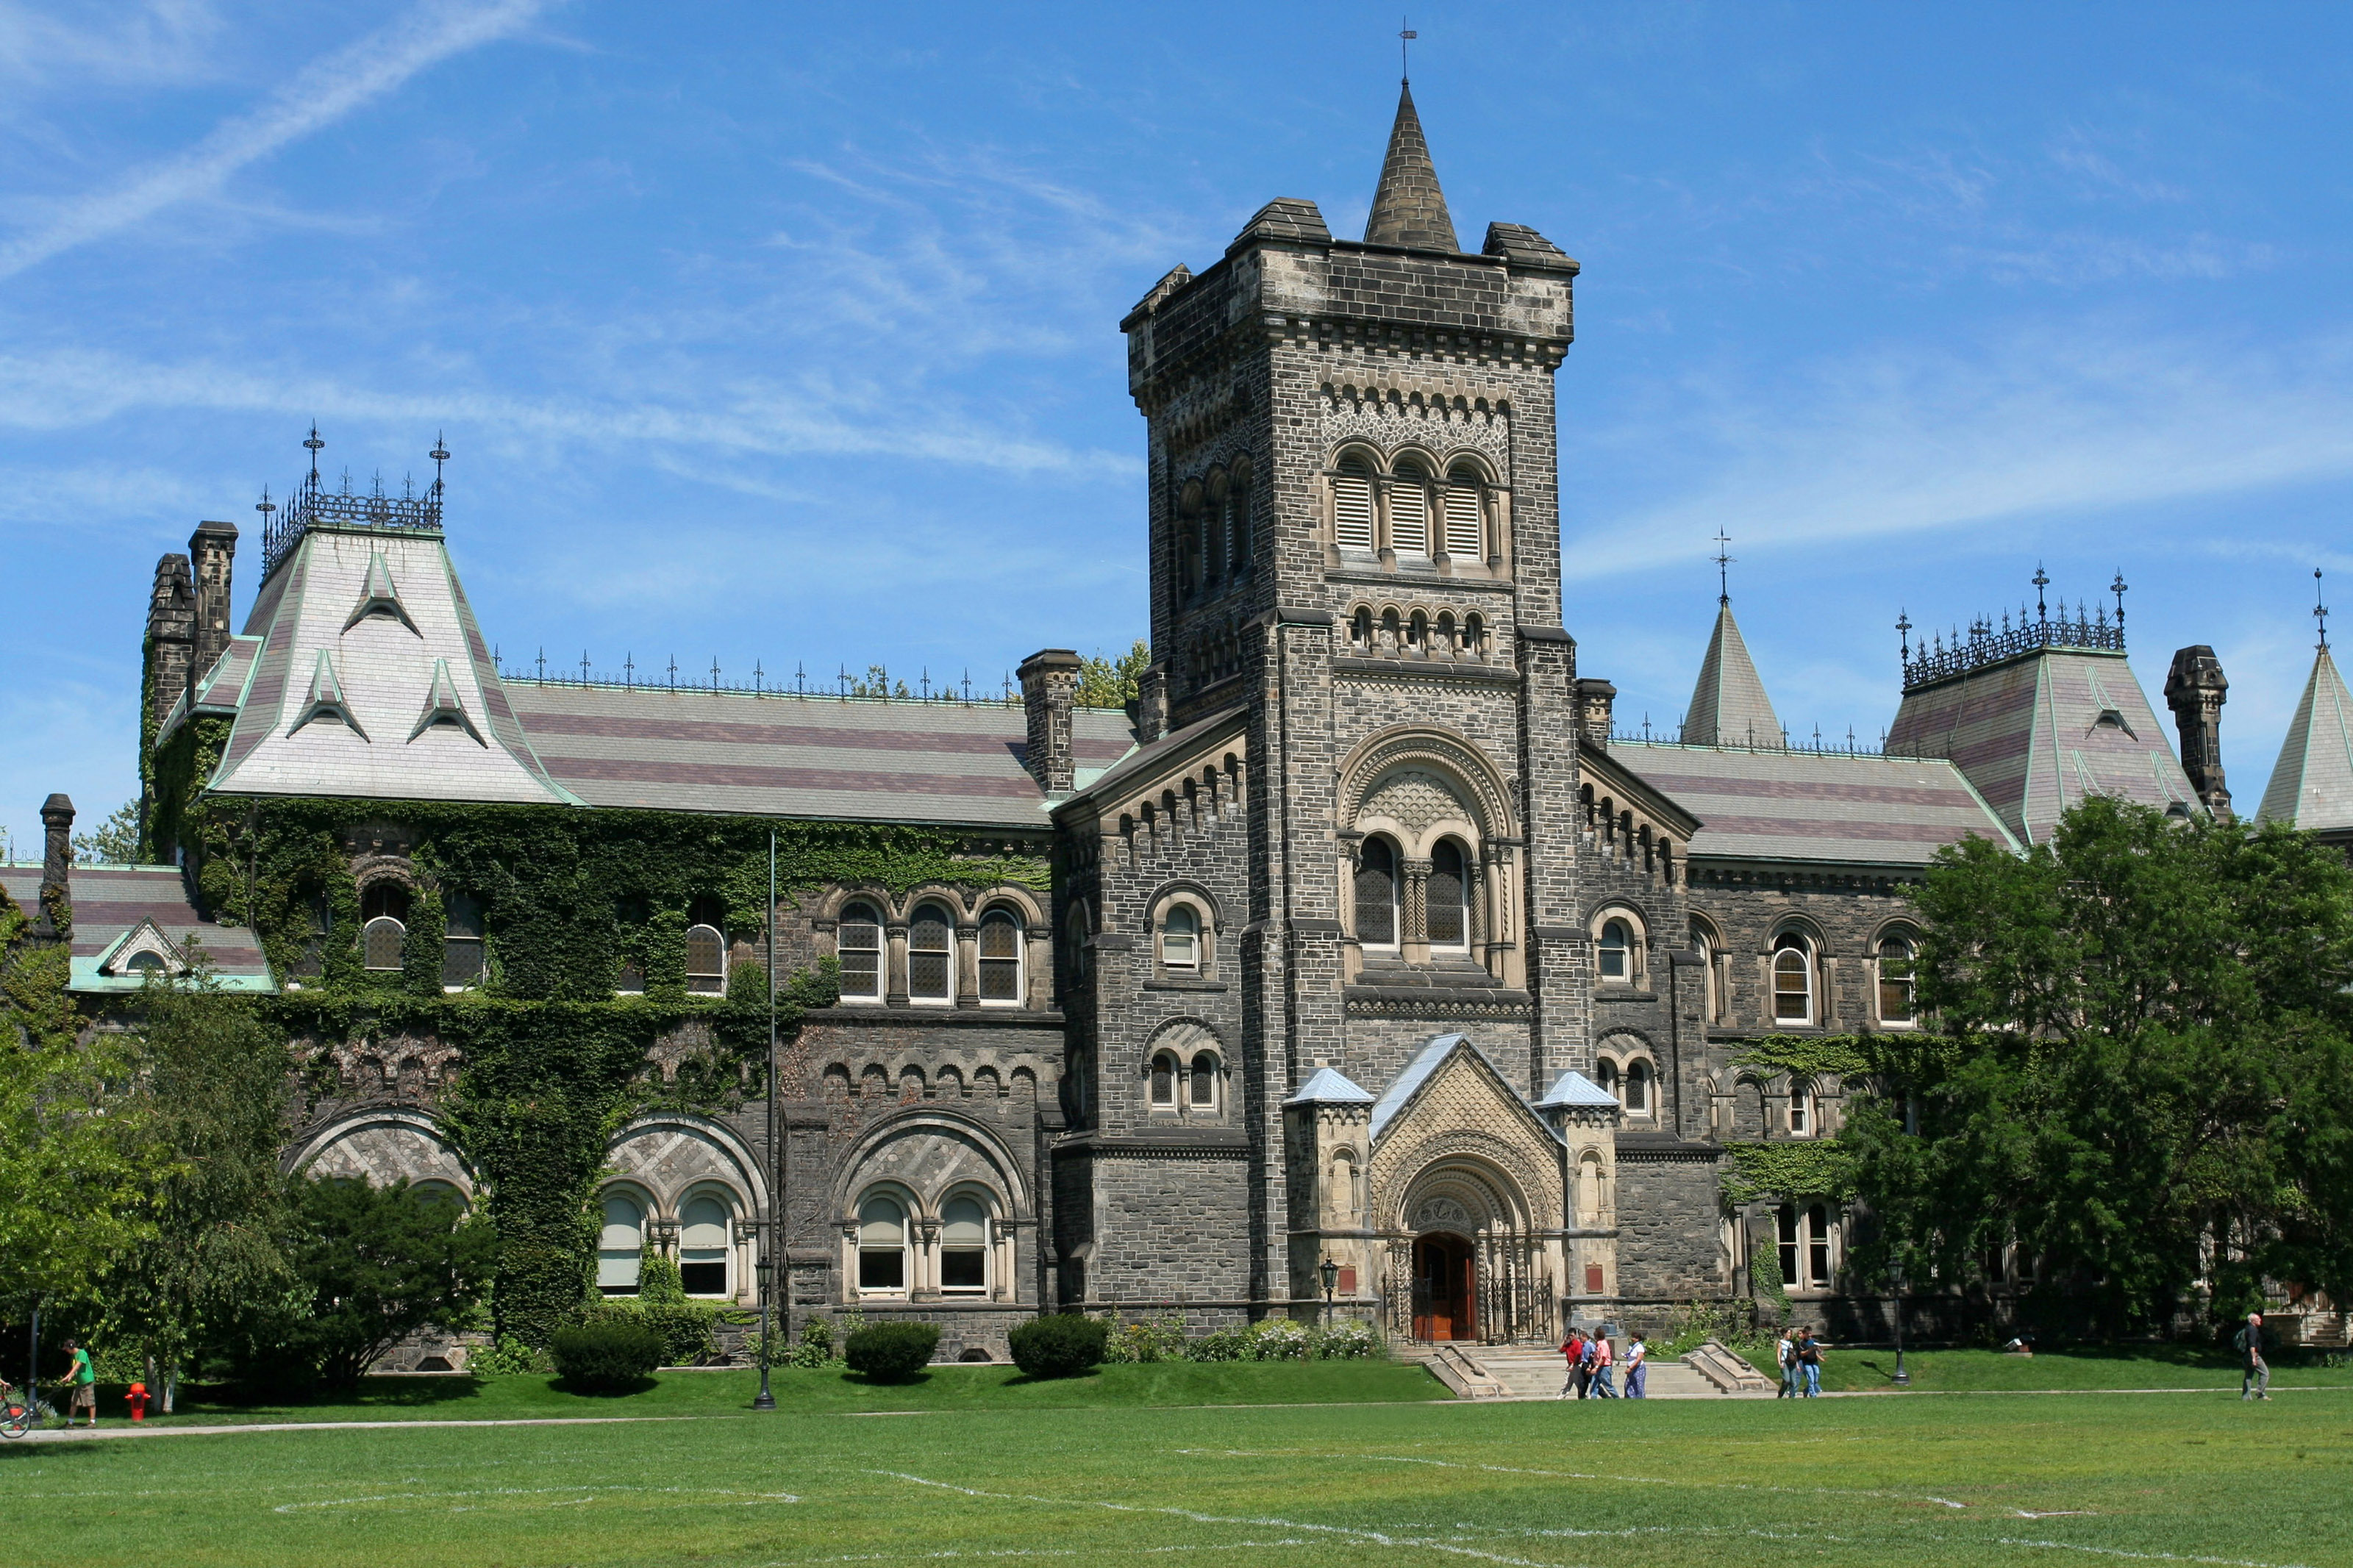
[155,790,1049,1345]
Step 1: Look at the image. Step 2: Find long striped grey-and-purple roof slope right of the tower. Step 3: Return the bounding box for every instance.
[1610,740,2016,867]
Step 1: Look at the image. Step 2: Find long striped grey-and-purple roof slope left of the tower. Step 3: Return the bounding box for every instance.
[506,679,1134,828]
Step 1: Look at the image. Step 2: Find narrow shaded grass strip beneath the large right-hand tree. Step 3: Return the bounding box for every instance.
[1749,1345,2353,1394]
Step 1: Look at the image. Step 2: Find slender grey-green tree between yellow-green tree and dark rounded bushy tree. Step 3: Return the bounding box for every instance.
[108,966,292,1411]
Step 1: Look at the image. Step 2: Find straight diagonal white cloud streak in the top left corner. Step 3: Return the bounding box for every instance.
[0,0,546,277]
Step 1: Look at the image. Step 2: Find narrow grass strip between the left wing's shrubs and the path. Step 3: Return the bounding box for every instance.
[74,1361,1447,1427]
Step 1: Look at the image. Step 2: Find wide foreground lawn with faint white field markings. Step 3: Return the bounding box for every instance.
[0,1368,2353,1568]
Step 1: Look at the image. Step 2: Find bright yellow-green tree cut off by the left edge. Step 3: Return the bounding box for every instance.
[0,893,155,1314]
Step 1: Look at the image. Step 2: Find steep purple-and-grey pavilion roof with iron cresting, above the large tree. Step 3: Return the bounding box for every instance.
[1887,649,2198,844]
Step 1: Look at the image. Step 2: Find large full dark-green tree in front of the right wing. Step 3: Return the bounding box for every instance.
[1845,797,2353,1333]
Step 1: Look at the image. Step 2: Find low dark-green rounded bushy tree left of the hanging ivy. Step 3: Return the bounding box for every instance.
[285,1180,496,1387]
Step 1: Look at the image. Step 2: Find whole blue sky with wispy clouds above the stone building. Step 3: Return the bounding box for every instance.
[0,0,2353,846]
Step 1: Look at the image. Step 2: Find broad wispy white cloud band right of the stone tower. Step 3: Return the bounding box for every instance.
[1567,332,2353,579]
